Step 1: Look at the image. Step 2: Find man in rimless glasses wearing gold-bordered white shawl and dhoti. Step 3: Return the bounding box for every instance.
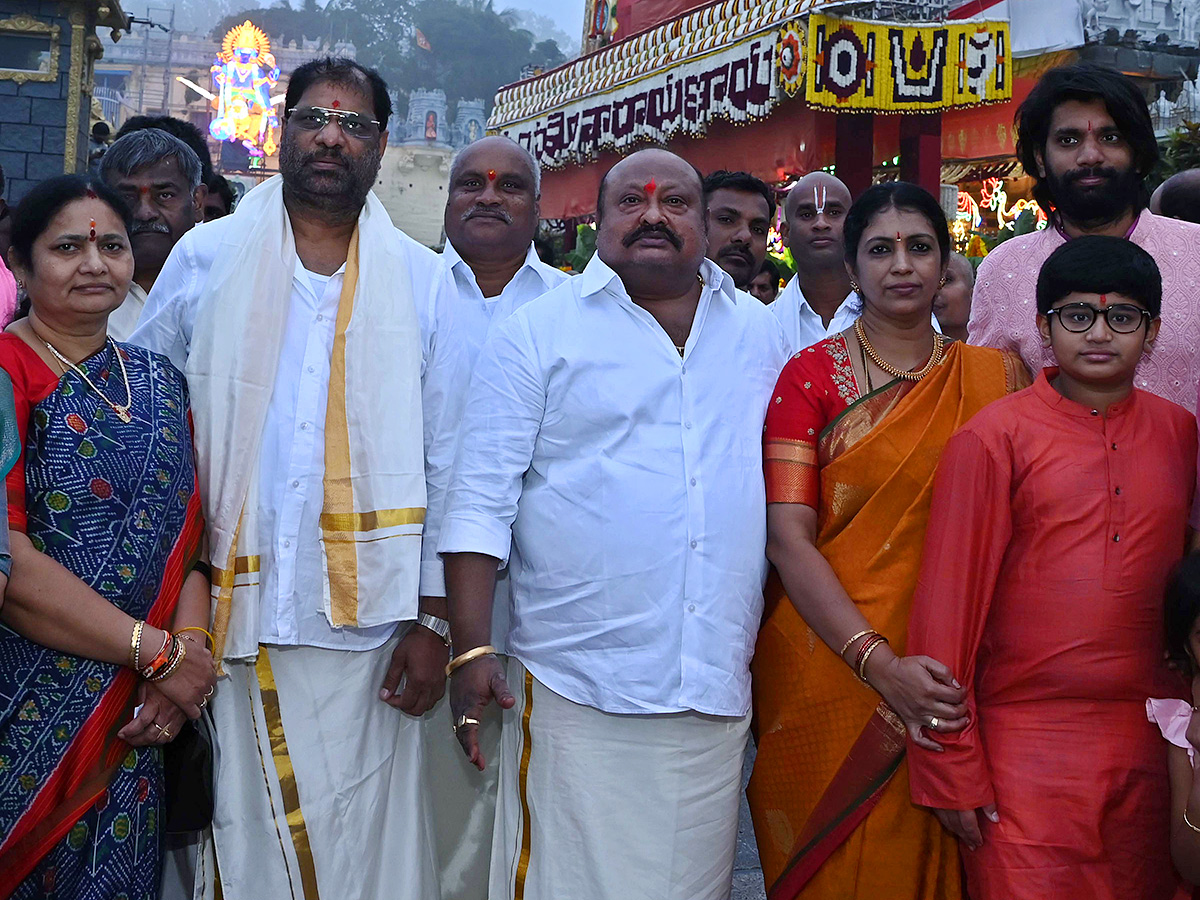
[133,58,448,900]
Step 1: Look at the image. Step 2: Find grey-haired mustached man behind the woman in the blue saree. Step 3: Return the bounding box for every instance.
[100,128,208,341]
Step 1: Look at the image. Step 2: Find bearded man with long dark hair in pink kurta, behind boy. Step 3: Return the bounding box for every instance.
[968,64,1200,410]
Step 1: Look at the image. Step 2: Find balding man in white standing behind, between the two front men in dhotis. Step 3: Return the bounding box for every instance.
[421,137,569,900]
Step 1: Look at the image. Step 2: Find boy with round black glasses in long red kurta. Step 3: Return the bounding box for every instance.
[908,236,1196,900]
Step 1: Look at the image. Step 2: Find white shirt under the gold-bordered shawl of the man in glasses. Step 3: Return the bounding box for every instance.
[131,213,440,650]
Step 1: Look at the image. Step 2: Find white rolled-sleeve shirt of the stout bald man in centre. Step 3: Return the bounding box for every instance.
[438,256,788,715]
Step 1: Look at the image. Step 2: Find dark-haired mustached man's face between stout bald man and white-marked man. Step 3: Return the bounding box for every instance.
[704,169,775,290]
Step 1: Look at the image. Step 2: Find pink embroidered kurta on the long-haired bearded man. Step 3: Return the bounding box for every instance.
[968,211,1200,412]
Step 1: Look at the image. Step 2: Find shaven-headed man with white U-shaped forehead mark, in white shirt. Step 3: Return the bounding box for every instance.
[770,172,863,353]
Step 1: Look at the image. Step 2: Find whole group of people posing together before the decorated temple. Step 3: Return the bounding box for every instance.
[0,58,1200,900]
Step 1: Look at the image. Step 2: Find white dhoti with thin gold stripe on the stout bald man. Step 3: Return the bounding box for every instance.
[488,658,750,900]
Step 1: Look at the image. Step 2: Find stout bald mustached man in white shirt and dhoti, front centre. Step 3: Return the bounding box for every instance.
[438,150,787,900]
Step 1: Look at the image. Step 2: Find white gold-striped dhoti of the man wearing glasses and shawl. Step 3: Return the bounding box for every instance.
[212,636,439,900]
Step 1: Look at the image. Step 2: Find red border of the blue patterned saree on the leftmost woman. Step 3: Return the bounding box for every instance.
[0,484,204,896]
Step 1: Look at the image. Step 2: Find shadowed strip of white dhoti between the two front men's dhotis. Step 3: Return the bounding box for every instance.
[422,685,500,900]
